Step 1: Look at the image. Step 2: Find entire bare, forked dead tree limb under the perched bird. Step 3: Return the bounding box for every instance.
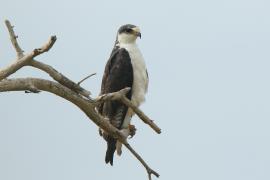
[0,20,161,180]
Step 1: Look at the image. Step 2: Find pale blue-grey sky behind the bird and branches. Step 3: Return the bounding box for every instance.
[0,0,270,180]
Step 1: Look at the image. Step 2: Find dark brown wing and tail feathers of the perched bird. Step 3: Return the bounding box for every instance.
[99,48,133,165]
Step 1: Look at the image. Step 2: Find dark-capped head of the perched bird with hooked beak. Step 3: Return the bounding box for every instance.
[117,24,141,43]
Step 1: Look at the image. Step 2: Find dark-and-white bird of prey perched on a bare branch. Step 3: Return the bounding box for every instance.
[98,24,148,165]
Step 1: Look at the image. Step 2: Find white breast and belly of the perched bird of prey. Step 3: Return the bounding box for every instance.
[120,43,148,107]
